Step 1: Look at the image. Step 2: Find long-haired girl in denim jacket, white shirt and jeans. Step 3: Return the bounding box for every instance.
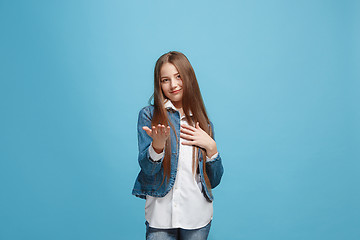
[132,51,224,240]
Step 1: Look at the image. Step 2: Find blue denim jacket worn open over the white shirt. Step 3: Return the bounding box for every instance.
[132,105,224,202]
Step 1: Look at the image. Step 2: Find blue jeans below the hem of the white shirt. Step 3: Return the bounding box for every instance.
[145,221,211,240]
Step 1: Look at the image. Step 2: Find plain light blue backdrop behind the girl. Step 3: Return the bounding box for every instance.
[0,0,360,240]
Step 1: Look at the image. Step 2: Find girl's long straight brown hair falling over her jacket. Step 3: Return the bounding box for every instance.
[149,51,213,192]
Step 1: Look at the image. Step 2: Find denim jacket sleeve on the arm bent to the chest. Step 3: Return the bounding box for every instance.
[205,121,224,188]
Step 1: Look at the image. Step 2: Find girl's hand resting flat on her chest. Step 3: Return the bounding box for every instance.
[180,122,217,157]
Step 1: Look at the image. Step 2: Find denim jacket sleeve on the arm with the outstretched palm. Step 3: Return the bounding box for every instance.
[137,107,164,176]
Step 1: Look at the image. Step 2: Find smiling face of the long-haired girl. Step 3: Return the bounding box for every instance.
[160,63,183,108]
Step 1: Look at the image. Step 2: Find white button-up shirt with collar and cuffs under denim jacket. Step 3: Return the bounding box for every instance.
[145,101,218,229]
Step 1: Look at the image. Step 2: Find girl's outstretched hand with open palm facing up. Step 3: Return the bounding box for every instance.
[142,124,170,153]
